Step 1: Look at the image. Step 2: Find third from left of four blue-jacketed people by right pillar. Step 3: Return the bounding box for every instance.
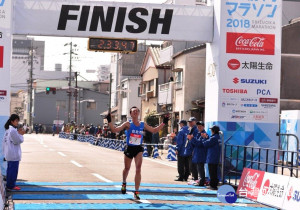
[192,121,209,186]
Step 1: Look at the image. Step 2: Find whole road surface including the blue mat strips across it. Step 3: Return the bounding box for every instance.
[9,134,274,210]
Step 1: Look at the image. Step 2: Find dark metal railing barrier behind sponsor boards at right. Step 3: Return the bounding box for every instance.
[222,144,299,186]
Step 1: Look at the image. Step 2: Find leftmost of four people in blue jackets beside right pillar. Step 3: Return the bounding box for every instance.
[175,120,192,181]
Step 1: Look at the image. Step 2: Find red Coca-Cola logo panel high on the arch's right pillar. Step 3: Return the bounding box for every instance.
[226,32,275,55]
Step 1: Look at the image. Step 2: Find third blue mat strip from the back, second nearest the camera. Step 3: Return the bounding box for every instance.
[12,194,255,204]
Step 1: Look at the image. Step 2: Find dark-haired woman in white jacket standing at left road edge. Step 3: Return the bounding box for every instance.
[3,114,25,190]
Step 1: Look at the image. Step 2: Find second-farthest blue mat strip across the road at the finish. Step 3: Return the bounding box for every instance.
[18,187,217,195]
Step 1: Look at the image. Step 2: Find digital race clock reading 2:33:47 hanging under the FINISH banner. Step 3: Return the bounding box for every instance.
[88,37,137,53]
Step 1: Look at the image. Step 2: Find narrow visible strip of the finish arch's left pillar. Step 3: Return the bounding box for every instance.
[0,0,12,182]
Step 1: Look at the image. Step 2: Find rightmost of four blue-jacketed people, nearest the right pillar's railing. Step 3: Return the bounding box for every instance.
[200,125,220,190]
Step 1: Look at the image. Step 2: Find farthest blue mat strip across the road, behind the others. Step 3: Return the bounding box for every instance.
[16,182,205,189]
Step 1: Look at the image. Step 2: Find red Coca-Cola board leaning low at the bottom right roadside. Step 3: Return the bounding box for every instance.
[237,168,265,200]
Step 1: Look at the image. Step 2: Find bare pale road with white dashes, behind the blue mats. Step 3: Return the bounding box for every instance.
[18,134,177,183]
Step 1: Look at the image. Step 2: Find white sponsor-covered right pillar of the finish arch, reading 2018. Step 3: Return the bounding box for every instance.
[205,0,282,170]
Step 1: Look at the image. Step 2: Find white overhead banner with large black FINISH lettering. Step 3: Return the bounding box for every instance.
[13,0,213,42]
